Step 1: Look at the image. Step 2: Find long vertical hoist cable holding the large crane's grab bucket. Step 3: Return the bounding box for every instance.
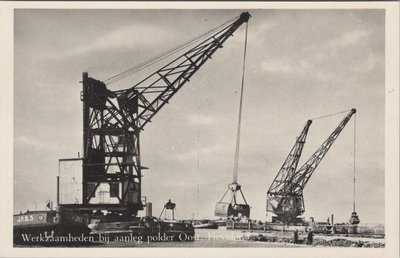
[233,22,249,183]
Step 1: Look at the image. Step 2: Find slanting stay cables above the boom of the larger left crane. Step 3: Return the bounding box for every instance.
[103,17,238,84]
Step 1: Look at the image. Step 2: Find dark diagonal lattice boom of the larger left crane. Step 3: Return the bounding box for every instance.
[115,12,250,129]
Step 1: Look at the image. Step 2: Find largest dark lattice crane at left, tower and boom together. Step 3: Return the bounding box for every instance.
[58,12,250,216]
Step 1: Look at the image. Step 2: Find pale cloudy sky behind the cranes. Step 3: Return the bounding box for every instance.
[14,9,385,223]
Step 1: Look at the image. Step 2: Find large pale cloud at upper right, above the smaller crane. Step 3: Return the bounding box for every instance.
[260,27,381,81]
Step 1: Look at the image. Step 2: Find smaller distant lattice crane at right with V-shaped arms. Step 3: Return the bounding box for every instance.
[266,109,356,223]
